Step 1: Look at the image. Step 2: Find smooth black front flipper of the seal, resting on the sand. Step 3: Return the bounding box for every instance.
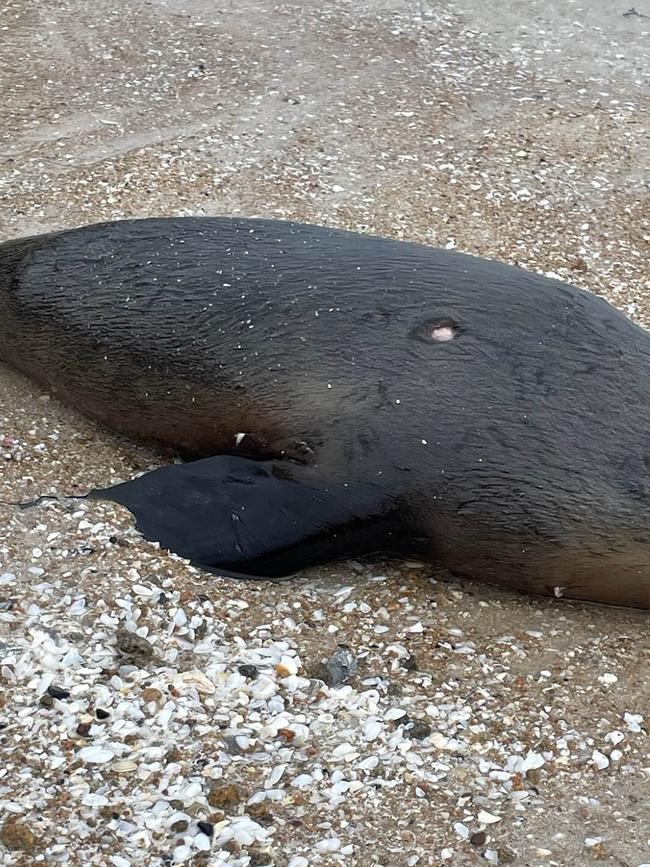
[88,455,401,578]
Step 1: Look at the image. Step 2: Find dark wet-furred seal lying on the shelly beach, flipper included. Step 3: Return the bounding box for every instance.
[0,217,650,607]
